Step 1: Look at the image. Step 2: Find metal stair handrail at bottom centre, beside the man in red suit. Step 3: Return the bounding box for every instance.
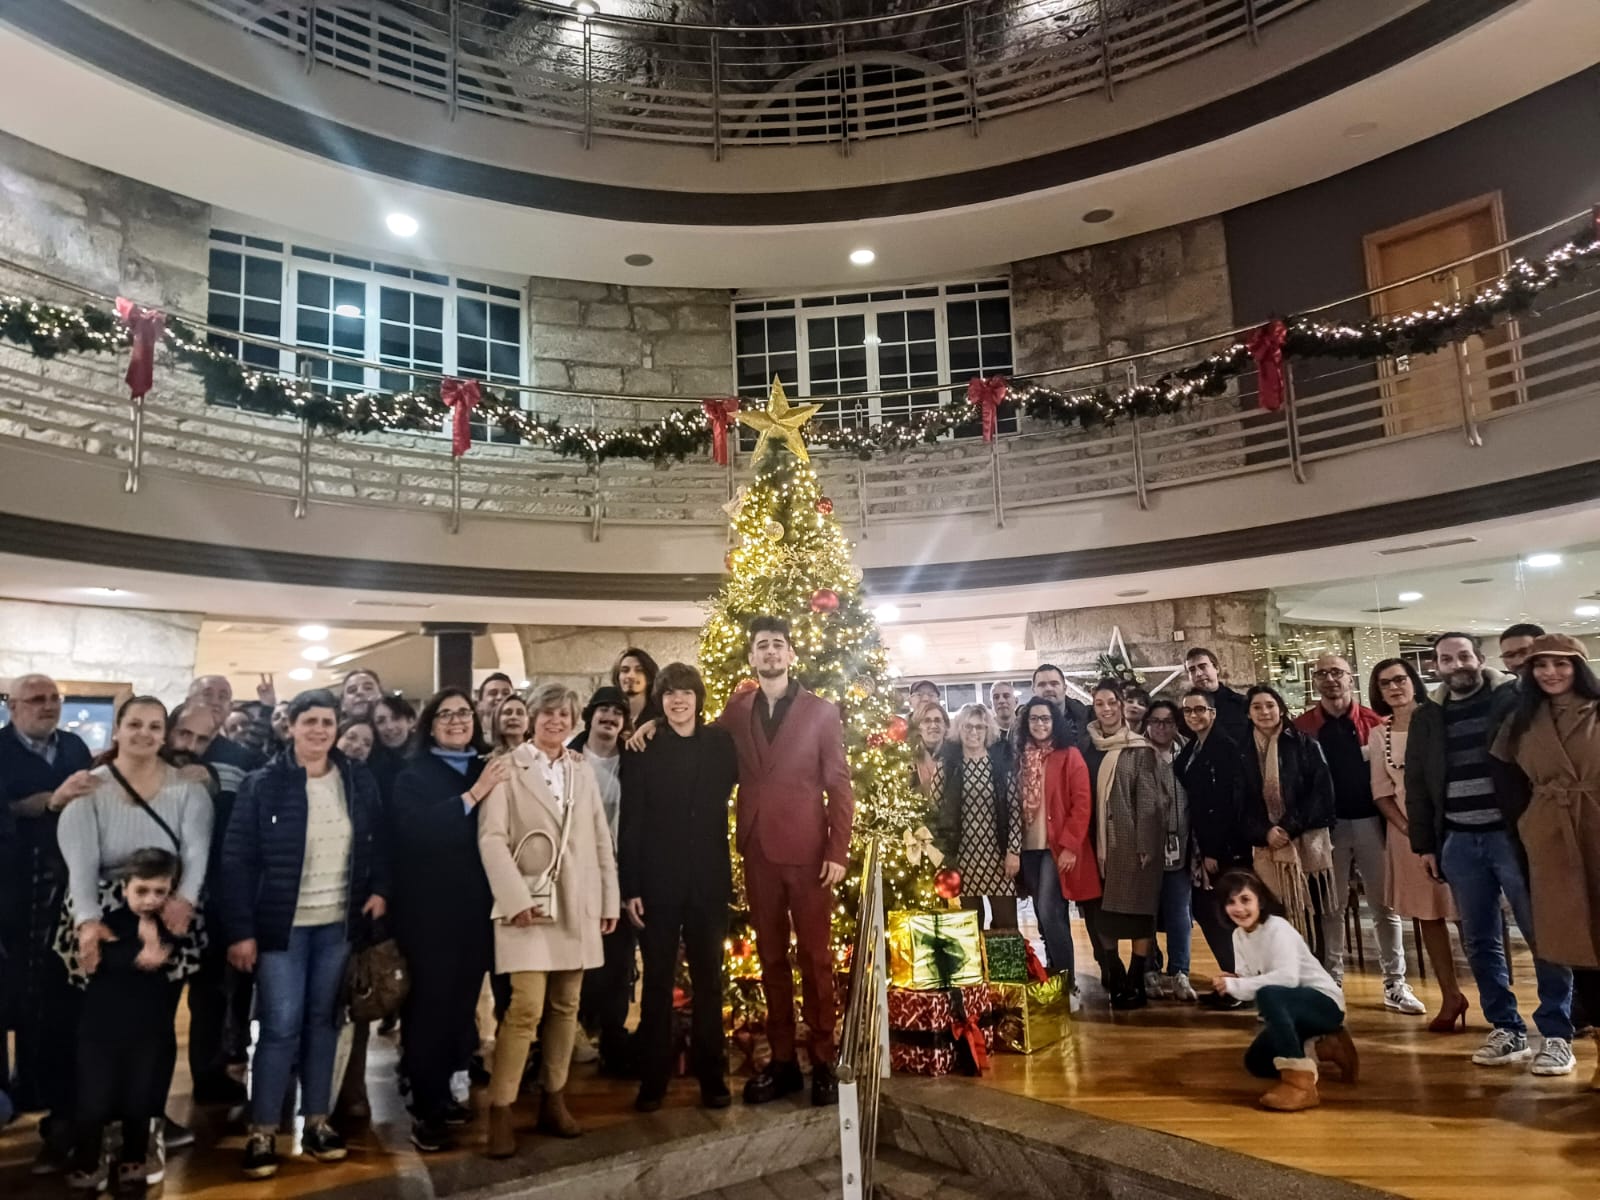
[834,837,890,1200]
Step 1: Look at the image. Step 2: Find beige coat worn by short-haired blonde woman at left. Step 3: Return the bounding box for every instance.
[478,742,621,973]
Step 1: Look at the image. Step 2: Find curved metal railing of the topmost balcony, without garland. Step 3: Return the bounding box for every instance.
[186,0,1312,158]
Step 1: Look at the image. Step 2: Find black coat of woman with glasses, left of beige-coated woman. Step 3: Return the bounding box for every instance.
[387,750,494,946]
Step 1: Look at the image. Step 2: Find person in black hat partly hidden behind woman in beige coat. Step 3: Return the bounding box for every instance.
[571,688,635,1077]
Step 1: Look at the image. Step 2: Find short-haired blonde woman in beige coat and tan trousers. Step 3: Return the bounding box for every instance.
[478,683,619,1158]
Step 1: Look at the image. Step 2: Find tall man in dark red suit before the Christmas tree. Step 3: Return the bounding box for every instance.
[717,616,856,1104]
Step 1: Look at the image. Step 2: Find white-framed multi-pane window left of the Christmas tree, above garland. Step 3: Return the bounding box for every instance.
[208,229,526,440]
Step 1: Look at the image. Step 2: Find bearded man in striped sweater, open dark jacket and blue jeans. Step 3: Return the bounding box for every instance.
[1405,634,1574,1075]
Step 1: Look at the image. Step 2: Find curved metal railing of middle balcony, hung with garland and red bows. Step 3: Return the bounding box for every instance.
[0,212,1600,538]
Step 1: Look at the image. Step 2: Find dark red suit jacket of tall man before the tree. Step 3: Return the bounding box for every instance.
[717,688,856,870]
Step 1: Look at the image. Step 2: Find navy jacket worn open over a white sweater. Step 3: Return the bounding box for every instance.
[218,750,392,952]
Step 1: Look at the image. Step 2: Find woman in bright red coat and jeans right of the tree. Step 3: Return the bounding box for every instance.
[1013,696,1099,998]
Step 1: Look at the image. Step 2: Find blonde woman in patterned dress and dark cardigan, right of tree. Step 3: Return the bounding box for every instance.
[930,704,1022,930]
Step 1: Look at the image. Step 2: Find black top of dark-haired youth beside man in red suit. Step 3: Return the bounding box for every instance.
[616,722,739,922]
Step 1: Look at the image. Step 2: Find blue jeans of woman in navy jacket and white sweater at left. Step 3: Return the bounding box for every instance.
[250,922,350,1128]
